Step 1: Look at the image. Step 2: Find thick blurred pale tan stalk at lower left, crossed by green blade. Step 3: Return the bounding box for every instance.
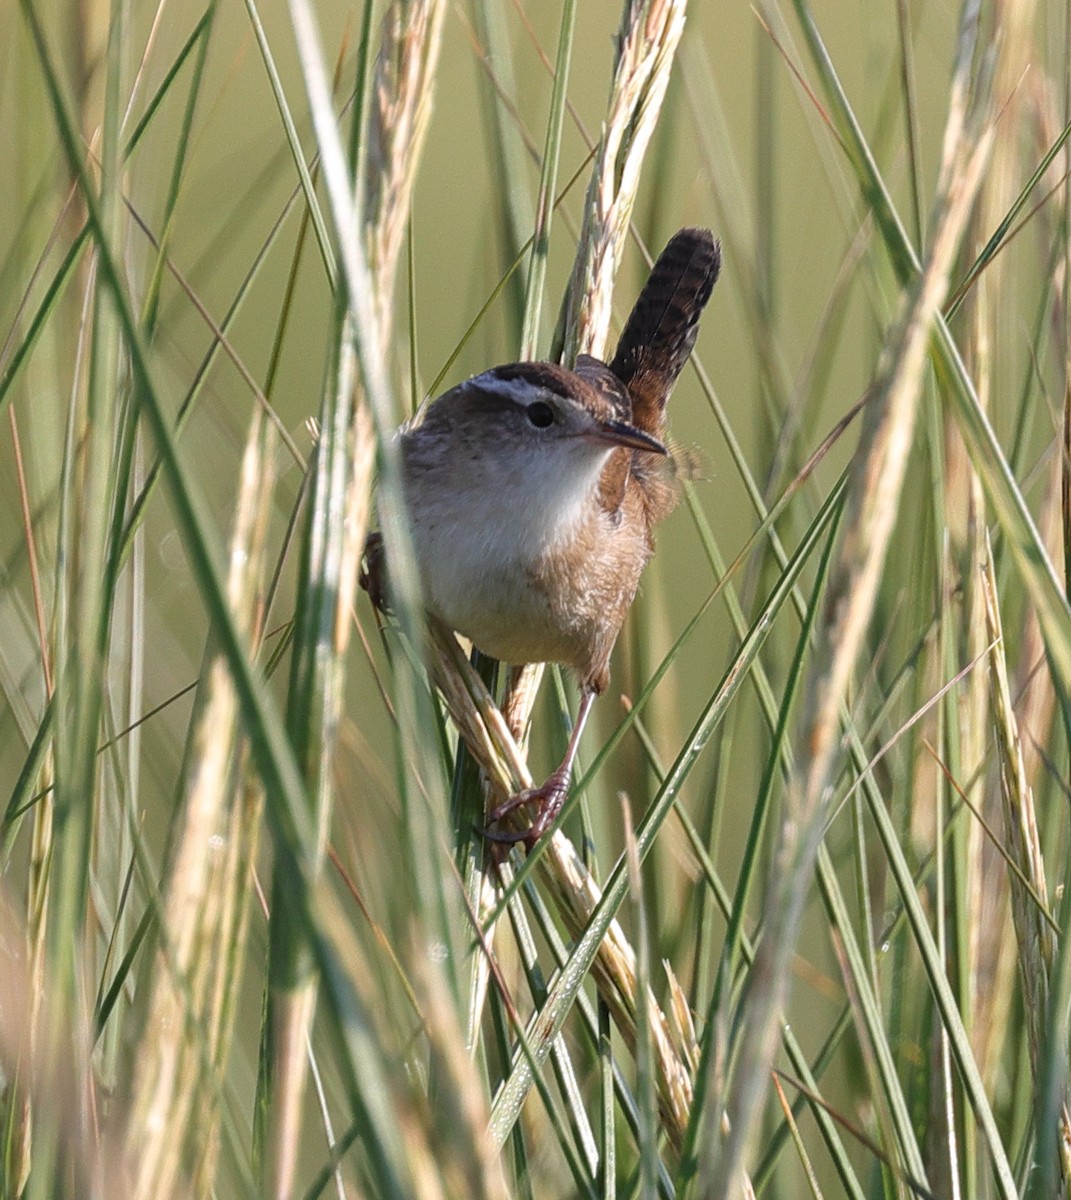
[124,409,276,1200]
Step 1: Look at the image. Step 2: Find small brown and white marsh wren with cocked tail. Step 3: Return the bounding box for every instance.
[361,229,720,847]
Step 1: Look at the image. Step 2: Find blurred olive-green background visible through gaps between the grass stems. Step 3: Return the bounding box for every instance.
[0,0,1067,1194]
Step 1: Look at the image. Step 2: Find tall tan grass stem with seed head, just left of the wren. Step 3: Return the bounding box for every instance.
[267,0,444,1198]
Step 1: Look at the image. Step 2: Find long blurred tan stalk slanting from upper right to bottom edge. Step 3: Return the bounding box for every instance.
[708,68,992,1196]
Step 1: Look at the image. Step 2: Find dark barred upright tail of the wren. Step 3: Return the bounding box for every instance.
[610,229,722,437]
